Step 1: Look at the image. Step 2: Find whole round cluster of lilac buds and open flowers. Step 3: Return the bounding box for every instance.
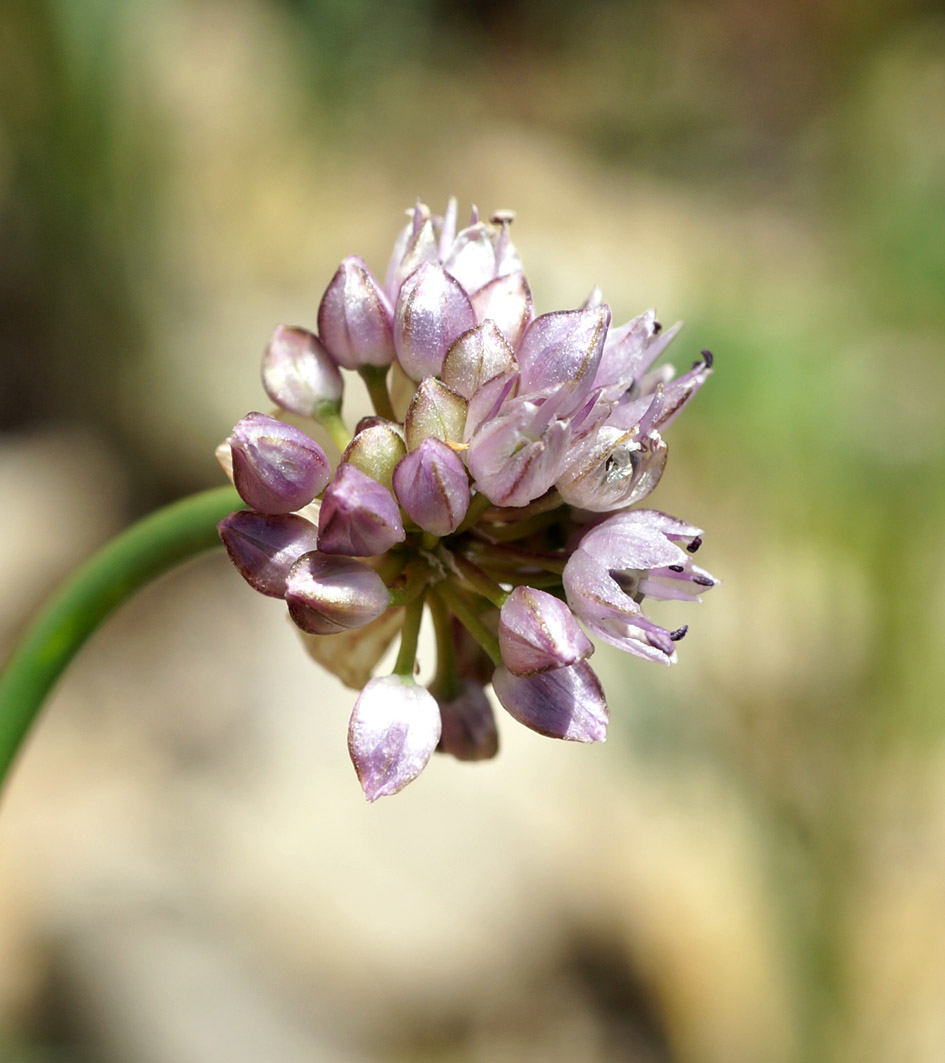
[218,201,716,800]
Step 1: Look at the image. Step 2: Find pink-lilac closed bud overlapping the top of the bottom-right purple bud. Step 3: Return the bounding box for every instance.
[499,587,594,676]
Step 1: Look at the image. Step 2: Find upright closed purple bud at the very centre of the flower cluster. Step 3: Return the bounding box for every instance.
[393,436,469,537]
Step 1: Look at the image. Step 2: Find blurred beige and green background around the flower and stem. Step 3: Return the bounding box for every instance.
[0,0,945,1063]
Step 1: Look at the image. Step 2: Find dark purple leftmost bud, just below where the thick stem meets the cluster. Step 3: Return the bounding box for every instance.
[217,509,317,597]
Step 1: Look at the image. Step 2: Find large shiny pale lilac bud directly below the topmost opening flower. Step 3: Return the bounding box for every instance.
[393,263,476,381]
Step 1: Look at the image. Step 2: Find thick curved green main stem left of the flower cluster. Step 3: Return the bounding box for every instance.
[0,487,243,783]
